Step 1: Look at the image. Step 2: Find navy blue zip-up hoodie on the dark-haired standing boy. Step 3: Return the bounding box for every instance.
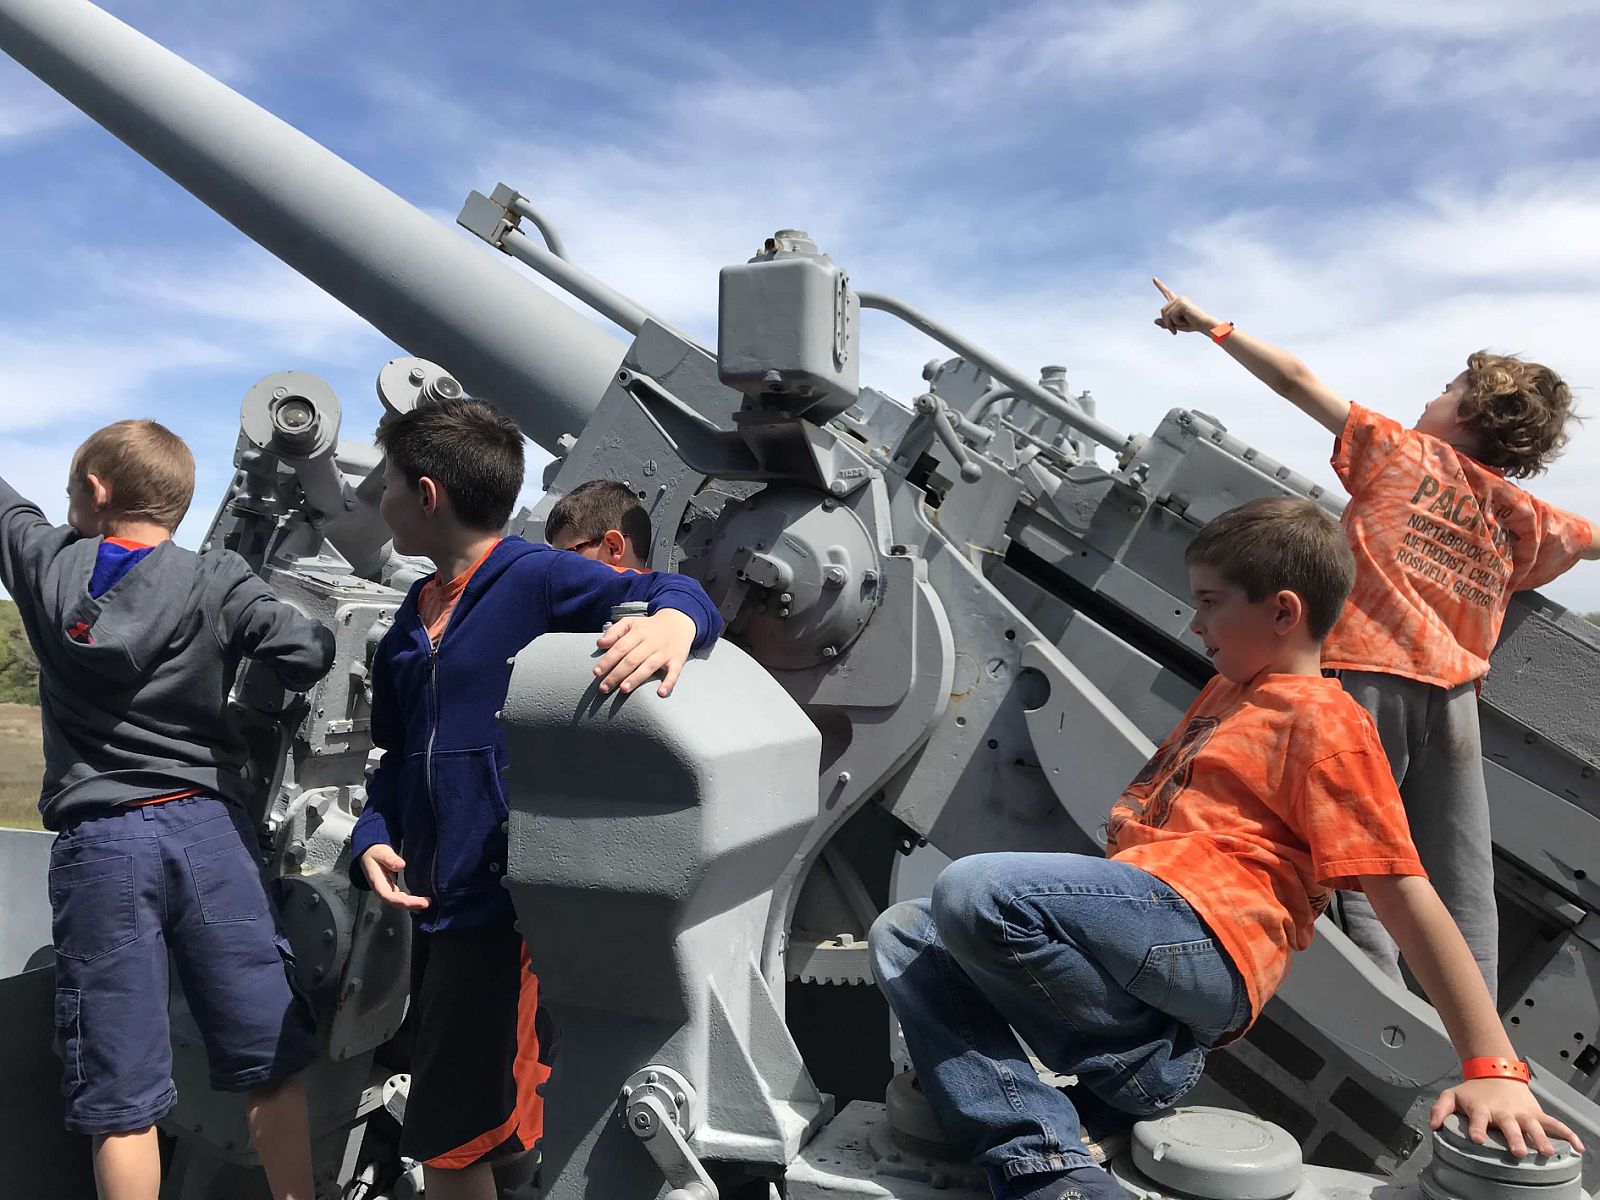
[350,538,722,933]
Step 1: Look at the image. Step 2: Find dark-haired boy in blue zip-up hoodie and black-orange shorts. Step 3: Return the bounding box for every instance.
[350,398,722,1200]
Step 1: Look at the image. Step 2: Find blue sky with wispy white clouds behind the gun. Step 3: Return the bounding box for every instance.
[0,0,1600,610]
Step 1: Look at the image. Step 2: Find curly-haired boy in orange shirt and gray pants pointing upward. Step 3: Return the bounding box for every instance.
[1155,280,1600,995]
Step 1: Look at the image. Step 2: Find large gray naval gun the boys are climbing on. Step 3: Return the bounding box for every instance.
[0,0,1600,1200]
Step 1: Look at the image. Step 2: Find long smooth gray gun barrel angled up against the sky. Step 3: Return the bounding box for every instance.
[0,0,624,451]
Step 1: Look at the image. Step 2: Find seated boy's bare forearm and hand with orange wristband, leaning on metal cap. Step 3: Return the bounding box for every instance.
[1362,875,1584,1158]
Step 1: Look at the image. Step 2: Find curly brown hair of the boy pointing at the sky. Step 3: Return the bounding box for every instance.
[1456,350,1573,478]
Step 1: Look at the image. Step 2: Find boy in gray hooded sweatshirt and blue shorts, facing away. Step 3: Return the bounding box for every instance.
[0,421,333,1200]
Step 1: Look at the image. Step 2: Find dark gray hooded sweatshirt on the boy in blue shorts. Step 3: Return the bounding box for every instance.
[0,480,333,829]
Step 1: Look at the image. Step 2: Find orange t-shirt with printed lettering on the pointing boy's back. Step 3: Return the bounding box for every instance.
[1322,405,1594,688]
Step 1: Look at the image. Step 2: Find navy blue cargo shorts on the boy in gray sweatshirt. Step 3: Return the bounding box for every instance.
[50,795,317,1134]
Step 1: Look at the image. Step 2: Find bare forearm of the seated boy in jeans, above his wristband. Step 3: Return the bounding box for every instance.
[1362,875,1515,1059]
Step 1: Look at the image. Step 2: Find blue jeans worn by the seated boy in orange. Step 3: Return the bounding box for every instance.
[870,854,1250,1179]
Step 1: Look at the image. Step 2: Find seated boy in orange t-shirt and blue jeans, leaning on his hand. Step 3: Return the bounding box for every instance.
[870,499,1573,1200]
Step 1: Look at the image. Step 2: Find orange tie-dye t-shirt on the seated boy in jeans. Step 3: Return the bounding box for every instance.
[1106,675,1427,1037]
